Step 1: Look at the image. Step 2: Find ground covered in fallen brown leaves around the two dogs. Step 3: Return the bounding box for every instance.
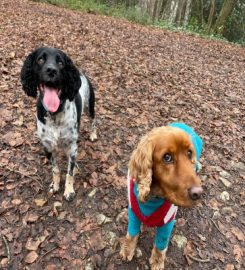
[0,0,245,270]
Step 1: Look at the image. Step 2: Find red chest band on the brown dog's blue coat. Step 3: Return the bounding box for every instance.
[130,179,176,227]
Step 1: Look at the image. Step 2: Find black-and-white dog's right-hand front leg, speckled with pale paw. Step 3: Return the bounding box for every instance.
[64,143,77,201]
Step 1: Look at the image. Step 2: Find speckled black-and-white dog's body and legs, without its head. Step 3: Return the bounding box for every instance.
[37,75,97,200]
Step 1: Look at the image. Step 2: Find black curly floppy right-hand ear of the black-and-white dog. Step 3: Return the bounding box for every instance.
[63,54,81,101]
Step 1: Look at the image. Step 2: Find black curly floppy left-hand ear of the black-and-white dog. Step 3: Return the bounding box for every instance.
[20,50,38,98]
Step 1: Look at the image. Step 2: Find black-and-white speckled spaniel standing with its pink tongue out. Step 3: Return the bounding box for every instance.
[21,47,97,201]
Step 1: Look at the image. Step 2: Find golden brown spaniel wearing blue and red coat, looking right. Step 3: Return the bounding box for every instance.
[120,124,203,270]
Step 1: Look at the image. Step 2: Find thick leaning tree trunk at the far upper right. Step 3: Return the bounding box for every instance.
[213,0,237,34]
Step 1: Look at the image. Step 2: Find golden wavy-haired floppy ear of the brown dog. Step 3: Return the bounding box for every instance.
[129,135,153,202]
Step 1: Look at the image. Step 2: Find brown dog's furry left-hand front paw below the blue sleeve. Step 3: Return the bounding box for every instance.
[120,234,138,261]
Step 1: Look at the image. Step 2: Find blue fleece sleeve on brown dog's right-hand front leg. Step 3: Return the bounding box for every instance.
[155,220,175,250]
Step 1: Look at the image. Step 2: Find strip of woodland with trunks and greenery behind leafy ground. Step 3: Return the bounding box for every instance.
[40,0,245,44]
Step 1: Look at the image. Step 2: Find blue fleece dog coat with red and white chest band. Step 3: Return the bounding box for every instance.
[128,123,203,250]
